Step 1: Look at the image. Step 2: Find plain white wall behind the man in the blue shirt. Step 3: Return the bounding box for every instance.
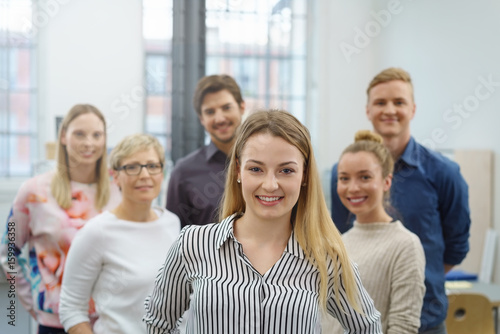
[310,0,500,283]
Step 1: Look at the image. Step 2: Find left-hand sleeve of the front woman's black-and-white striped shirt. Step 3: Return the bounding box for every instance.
[143,227,191,334]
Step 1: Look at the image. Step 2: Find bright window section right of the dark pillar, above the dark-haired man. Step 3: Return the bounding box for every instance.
[206,0,307,121]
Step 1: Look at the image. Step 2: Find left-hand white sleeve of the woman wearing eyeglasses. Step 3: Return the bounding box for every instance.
[59,216,105,331]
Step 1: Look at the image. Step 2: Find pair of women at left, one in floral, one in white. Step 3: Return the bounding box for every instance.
[0,104,180,334]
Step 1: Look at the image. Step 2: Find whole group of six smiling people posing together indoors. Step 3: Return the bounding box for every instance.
[0,68,470,334]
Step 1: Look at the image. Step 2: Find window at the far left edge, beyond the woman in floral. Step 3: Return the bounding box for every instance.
[0,0,37,177]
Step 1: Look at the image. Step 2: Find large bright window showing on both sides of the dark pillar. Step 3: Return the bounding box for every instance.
[143,0,307,146]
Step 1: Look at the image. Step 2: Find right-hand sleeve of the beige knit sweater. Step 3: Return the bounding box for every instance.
[387,236,425,334]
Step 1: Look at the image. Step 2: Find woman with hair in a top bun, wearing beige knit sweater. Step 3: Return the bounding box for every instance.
[327,130,425,334]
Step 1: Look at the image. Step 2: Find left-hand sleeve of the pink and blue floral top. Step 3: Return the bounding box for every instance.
[0,180,39,312]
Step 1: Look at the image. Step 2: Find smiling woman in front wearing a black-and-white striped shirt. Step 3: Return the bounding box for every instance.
[144,110,382,334]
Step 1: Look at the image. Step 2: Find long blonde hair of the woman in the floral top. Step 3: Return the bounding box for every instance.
[50,104,110,210]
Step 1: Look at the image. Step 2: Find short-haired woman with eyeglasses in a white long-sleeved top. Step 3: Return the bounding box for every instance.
[60,134,180,334]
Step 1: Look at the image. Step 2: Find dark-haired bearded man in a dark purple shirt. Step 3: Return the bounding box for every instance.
[167,75,245,227]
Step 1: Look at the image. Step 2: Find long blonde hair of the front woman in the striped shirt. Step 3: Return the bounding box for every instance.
[219,110,361,312]
